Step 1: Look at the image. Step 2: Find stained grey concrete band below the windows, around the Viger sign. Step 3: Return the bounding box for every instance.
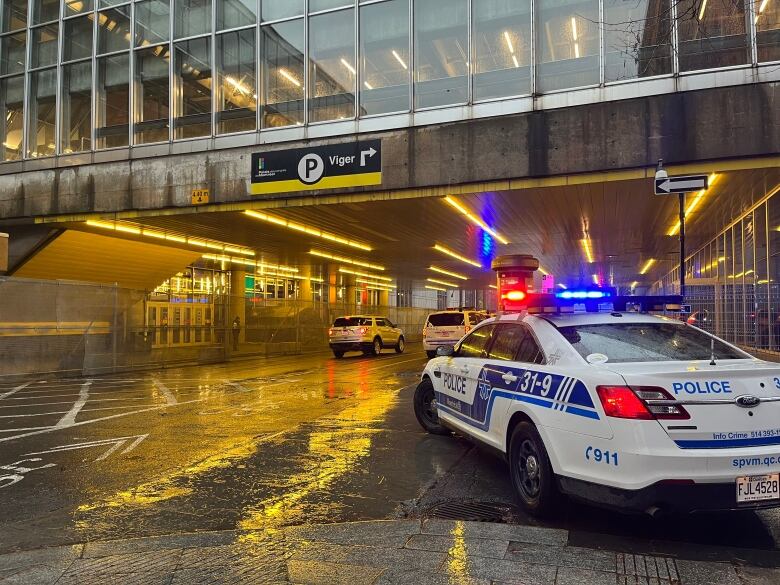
[0,83,780,219]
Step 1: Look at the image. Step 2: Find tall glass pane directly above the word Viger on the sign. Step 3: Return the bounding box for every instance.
[309,9,356,122]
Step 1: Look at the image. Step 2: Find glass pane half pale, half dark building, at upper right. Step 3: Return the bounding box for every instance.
[604,0,672,81]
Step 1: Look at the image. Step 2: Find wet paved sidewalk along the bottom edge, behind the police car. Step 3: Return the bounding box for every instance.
[0,520,780,585]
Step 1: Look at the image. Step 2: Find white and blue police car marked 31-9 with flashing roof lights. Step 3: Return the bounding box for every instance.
[414,292,780,515]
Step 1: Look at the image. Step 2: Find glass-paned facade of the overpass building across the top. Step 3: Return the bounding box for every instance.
[0,0,780,162]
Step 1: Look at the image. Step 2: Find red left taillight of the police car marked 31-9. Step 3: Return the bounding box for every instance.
[596,386,690,420]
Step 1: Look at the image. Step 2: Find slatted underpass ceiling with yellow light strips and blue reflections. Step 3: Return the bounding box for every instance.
[67,169,780,287]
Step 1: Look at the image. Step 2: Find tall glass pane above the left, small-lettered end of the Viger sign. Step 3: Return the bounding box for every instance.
[260,20,304,128]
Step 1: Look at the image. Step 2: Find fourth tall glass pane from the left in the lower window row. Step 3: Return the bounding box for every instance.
[95,53,130,148]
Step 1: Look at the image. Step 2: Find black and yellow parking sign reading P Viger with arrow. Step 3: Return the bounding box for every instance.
[252,140,382,195]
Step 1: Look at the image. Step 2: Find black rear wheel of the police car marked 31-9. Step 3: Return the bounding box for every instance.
[509,421,560,517]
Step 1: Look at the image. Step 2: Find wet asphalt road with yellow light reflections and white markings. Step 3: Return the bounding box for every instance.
[0,345,780,566]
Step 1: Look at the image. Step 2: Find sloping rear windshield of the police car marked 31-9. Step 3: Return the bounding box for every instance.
[558,323,748,363]
